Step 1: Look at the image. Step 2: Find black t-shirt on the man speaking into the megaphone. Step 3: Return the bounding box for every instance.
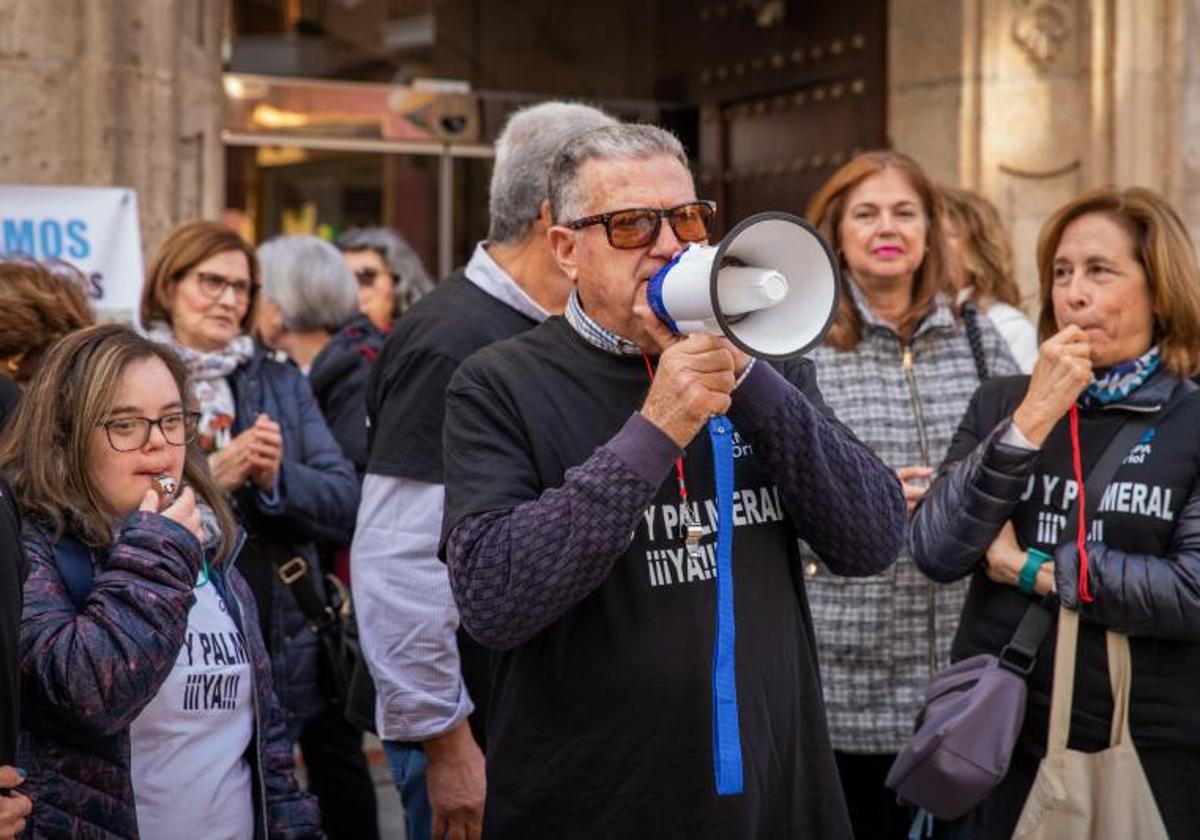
[443,318,850,839]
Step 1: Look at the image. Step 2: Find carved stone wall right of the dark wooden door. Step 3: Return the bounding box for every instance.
[889,0,1200,299]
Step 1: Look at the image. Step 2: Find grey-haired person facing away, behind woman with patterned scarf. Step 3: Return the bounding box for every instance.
[256,231,380,840]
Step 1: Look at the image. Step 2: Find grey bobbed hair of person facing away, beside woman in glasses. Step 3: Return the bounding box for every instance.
[258,236,359,332]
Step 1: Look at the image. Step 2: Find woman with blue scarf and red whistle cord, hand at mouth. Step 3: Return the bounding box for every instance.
[912,188,1200,840]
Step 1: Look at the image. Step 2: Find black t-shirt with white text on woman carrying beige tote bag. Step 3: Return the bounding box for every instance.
[946,374,1200,756]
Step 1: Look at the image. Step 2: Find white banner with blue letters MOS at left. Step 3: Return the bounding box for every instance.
[0,184,145,324]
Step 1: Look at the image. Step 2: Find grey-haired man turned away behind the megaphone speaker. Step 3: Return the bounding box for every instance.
[350,102,614,840]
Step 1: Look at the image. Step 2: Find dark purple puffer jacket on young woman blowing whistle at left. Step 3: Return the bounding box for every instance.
[19,511,322,840]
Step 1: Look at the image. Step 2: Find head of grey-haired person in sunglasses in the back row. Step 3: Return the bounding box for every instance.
[337,228,433,334]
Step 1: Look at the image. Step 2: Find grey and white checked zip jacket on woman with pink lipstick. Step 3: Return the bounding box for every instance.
[802,284,1019,754]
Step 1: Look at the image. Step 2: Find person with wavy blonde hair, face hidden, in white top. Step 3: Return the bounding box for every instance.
[942,187,1038,373]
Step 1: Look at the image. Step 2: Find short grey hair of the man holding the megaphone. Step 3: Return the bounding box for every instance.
[548,122,690,224]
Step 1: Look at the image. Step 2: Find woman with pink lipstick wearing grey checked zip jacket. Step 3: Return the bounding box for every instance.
[804,151,1016,840]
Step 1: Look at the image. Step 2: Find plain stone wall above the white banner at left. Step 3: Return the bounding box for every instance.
[0,0,224,254]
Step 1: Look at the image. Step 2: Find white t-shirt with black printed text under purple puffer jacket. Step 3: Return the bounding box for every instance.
[130,573,254,840]
